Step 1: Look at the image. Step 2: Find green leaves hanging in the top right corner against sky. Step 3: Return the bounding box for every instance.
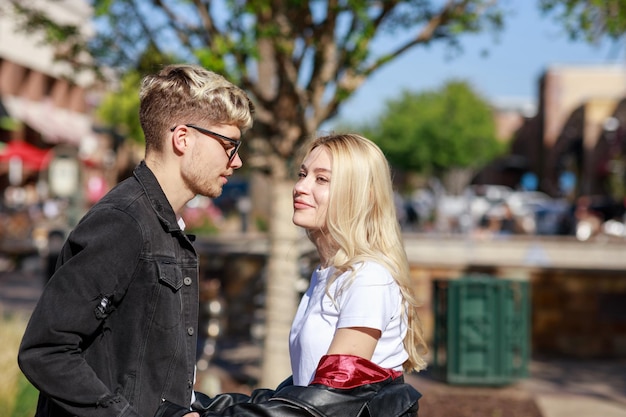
[539,0,626,43]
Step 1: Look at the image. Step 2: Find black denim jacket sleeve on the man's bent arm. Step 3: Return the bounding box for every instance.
[18,209,142,417]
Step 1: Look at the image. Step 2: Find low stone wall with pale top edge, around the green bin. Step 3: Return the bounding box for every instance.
[411,265,626,358]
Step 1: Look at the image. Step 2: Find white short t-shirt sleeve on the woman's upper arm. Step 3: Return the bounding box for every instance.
[337,262,400,331]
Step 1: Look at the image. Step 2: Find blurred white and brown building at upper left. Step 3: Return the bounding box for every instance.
[0,0,94,148]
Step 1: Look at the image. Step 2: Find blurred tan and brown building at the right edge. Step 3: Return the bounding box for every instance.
[474,65,626,204]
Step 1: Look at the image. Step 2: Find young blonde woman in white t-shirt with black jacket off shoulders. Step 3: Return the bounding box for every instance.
[155,134,426,417]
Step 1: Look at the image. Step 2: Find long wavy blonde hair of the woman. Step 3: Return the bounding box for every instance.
[305,134,427,372]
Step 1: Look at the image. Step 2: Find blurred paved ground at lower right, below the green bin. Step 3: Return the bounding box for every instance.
[409,358,626,417]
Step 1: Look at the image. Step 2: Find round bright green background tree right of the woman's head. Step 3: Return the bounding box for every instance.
[363,81,502,175]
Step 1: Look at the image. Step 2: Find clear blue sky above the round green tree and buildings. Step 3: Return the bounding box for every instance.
[330,0,626,124]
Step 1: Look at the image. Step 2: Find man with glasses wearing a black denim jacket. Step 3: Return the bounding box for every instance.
[18,65,254,417]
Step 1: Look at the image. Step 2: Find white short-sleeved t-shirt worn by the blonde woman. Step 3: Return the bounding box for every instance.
[289,262,408,386]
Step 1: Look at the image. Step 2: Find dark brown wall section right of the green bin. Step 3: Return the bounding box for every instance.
[532,271,626,358]
